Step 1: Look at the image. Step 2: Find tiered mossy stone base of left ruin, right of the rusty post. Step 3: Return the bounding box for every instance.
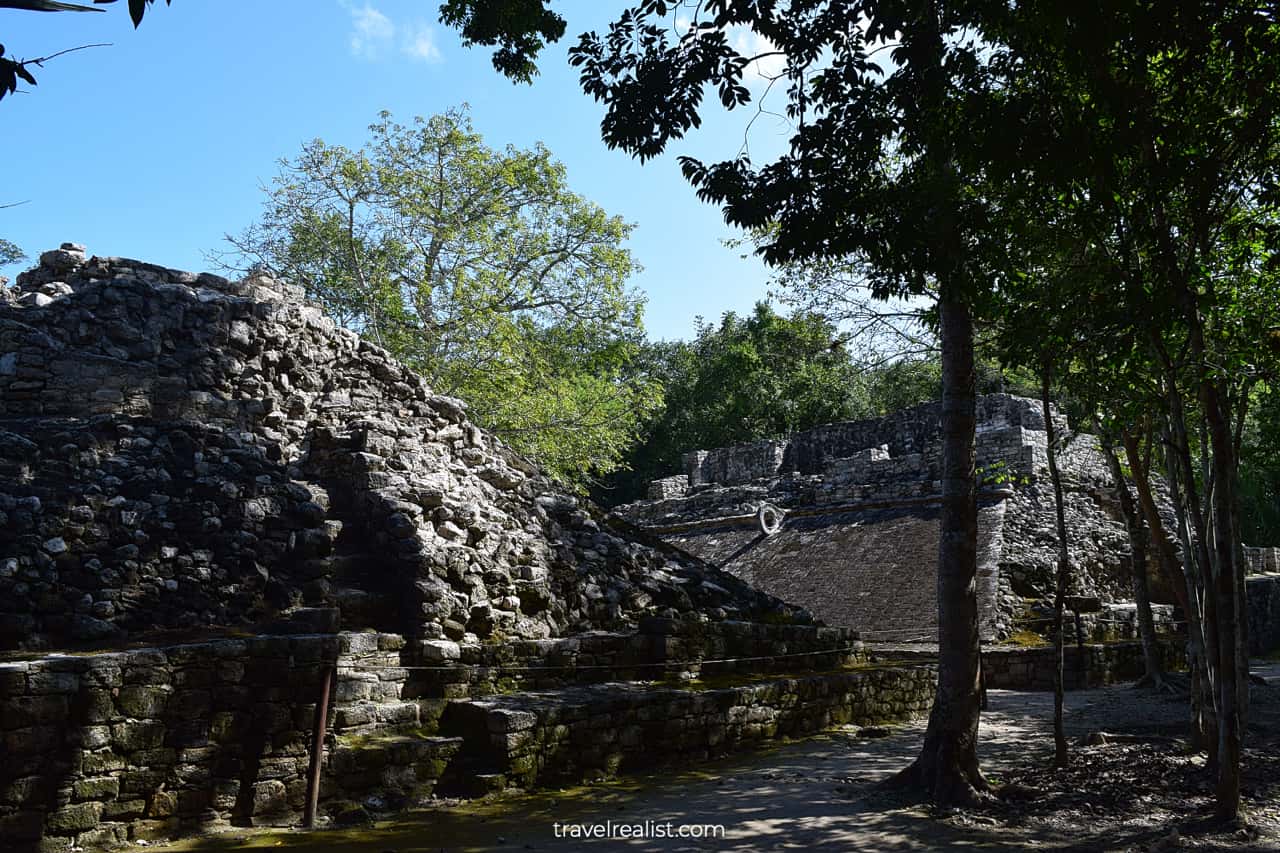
[314,619,936,802]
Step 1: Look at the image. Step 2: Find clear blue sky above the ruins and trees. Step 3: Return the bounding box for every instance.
[0,0,785,338]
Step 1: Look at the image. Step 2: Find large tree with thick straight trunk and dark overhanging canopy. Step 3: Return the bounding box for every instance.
[445,0,1039,802]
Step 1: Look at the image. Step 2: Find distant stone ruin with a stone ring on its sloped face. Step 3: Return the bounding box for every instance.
[617,394,1174,642]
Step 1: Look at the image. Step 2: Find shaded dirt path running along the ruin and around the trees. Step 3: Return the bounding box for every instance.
[165,663,1280,853]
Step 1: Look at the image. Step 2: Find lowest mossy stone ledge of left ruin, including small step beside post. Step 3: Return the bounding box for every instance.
[329,653,936,798]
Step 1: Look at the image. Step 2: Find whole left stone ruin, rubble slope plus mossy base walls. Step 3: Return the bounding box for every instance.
[0,243,933,850]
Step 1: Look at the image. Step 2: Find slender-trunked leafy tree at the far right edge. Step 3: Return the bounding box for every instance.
[1002,1,1280,818]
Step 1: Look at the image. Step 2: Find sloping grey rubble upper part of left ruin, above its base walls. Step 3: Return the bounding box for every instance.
[0,245,804,648]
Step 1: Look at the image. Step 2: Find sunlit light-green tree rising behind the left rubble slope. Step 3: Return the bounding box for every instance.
[229,108,659,488]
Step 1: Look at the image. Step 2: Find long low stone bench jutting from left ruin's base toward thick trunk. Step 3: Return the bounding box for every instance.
[440,666,936,795]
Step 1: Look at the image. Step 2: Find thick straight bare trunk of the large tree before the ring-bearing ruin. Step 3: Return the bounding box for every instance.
[896,288,989,804]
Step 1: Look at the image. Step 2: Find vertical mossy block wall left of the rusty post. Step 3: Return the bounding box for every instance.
[0,627,340,850]
